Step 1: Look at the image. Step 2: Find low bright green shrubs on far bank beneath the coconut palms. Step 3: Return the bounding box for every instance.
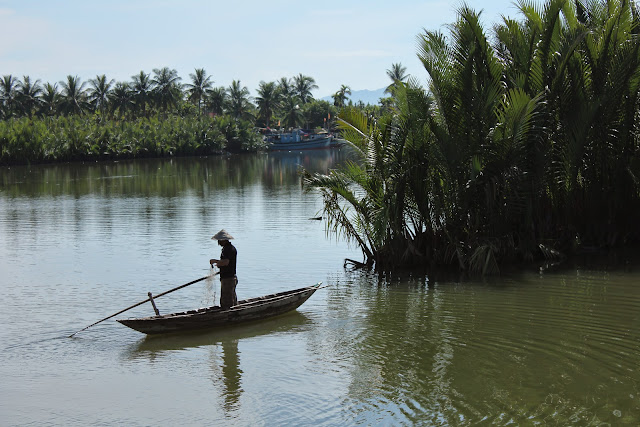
[0,115,262,164]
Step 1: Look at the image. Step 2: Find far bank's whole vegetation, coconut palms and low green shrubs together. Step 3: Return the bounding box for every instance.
[0,67,337,164]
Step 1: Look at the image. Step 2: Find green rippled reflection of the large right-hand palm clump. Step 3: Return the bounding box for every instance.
[318,270,640,425]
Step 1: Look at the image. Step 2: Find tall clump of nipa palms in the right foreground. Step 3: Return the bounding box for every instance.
[306,0,640,274]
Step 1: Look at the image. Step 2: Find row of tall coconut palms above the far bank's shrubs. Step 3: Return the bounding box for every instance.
[0,67,344,127]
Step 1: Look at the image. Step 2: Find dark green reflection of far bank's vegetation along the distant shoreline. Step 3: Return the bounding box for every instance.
[0,149,354,198]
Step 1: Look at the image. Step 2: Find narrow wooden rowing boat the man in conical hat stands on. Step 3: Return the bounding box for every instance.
[118,283,321,334]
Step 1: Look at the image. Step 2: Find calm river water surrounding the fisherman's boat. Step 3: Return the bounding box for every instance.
[0,149,640,426]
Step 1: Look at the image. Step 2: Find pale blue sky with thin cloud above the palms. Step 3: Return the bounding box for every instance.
[0,0,519,98]
